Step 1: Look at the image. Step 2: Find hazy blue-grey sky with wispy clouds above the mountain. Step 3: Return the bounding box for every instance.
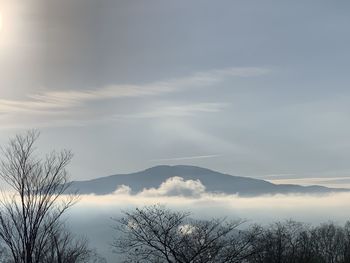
[0,0,350,185]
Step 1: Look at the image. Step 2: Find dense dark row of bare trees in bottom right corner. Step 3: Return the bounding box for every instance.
[247,220,350,263]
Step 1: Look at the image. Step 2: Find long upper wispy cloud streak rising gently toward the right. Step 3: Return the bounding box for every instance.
[0,67,270,112]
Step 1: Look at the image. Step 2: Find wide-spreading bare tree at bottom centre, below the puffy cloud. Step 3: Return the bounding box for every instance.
[113,205,249,263]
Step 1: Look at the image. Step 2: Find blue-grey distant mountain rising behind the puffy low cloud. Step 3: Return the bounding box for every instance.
[71,165,349,196]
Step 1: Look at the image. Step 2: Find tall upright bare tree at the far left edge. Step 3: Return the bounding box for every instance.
[0,131,87,263]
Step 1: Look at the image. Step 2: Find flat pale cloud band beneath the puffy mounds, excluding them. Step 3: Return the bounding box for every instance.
[76,191,350,227]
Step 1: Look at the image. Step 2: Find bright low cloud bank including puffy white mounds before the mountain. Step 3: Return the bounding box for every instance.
[78,177,350,223]
